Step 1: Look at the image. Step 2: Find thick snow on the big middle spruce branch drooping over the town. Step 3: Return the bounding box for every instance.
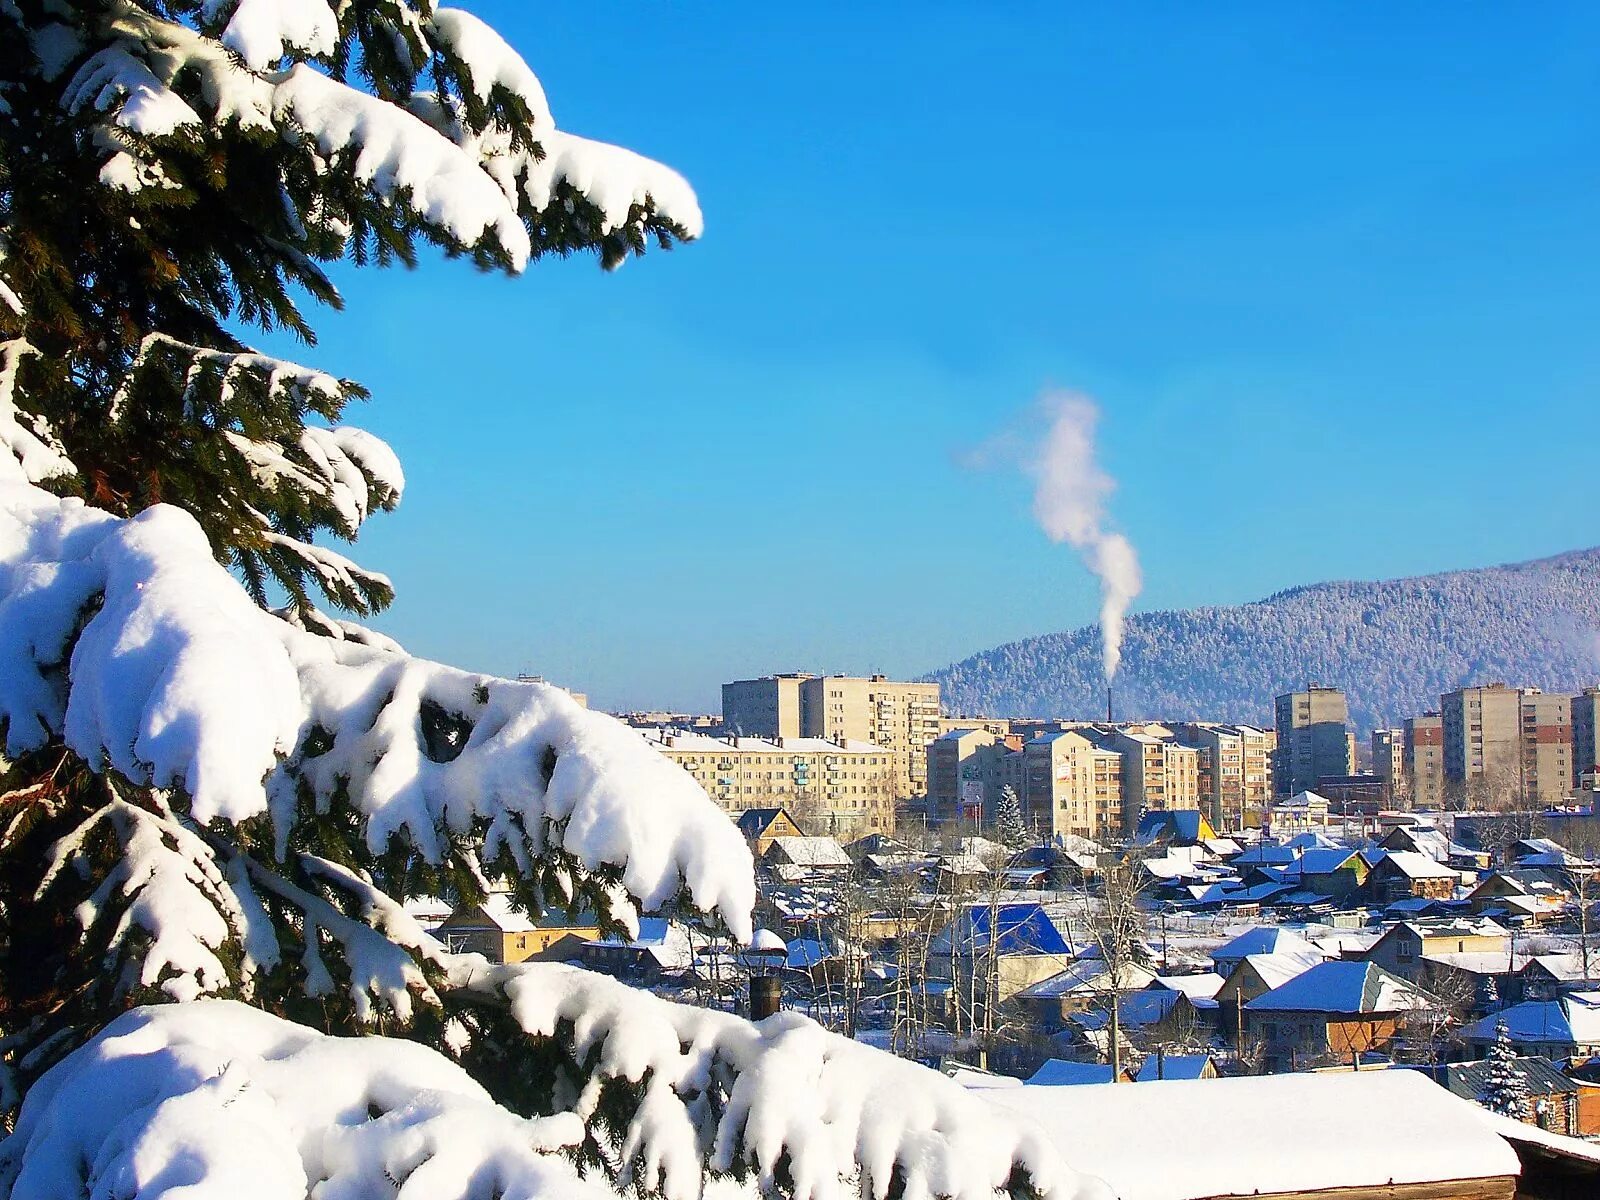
[0,454,755,938]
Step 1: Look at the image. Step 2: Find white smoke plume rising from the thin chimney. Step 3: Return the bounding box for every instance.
[998,392,1144,683]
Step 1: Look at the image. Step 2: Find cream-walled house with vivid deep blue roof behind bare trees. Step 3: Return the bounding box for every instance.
[928,904,1072,1003]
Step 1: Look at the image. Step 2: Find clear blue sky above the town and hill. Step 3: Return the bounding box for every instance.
[284,0,1600,709]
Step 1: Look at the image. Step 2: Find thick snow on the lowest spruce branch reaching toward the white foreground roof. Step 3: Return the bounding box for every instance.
[451,955,1102,1200]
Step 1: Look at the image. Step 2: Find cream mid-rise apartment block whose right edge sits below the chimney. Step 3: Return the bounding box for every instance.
[1019,731,1126,840]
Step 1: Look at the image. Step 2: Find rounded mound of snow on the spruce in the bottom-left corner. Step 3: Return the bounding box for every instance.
[0,1000,618,1200]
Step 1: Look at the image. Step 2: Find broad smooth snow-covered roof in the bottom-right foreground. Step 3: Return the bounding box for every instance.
[979,1070,1518,1200]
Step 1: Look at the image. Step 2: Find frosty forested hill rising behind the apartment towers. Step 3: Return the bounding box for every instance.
[928,547,1600,733]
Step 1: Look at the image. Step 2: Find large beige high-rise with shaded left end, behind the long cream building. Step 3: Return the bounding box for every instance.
[722,674,941,800]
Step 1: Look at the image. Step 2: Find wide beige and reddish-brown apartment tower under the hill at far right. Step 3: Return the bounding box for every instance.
[1438,683,1573,808]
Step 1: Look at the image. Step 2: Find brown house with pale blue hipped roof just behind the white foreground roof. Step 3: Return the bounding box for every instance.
[1245,960,1438,1070]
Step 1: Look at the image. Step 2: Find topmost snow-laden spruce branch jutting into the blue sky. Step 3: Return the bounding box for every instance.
[37,0,702,269]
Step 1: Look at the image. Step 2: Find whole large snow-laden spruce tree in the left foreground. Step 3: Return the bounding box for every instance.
[0,0,1093,1200]
